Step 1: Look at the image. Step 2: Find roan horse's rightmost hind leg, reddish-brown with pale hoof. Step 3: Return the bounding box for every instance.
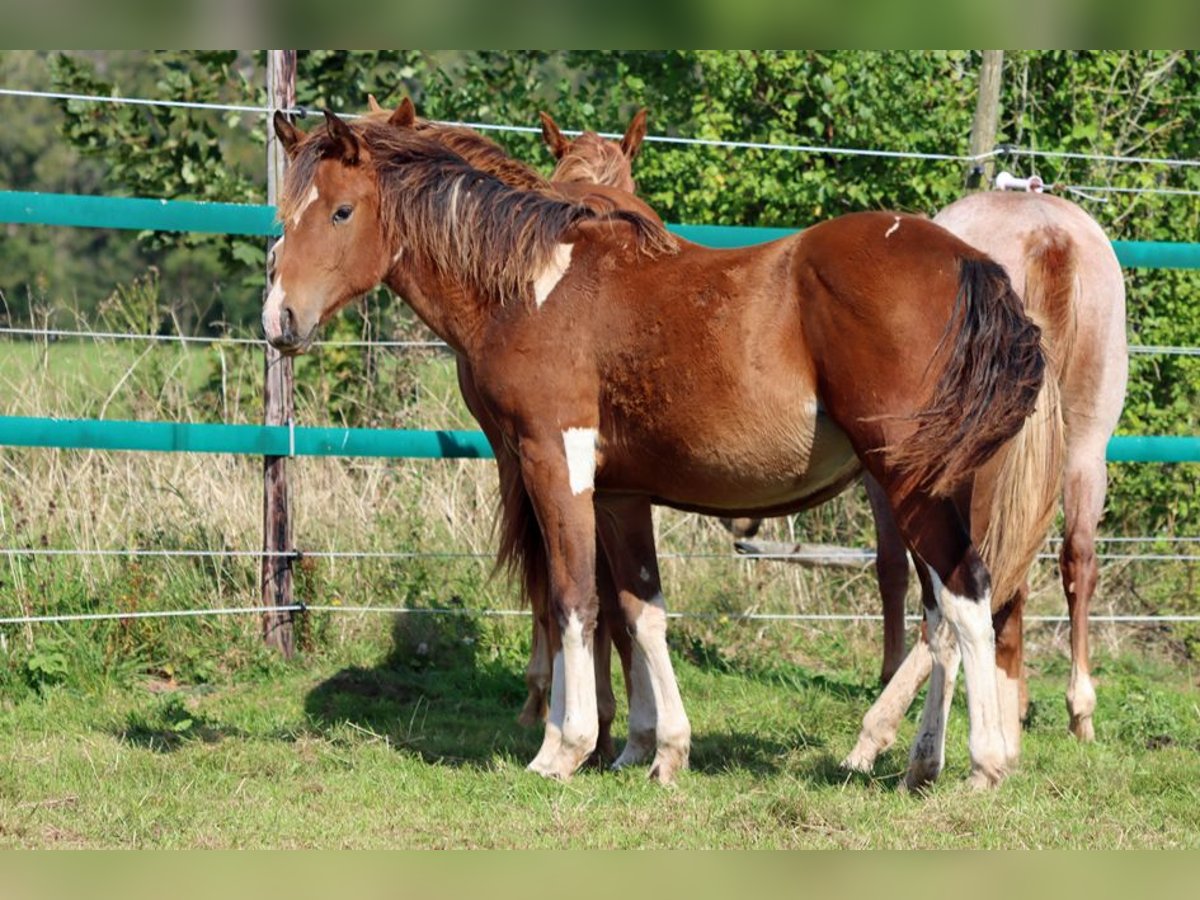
[1060,448,1108,742]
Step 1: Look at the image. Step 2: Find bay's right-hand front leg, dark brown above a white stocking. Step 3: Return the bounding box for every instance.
[596,498,691,784]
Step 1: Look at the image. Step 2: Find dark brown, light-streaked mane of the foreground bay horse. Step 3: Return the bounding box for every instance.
[280,115,676,302]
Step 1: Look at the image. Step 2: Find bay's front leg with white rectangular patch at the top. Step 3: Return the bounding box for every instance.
[518,428,599,779]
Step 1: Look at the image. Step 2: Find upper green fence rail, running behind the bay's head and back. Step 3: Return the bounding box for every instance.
[0,191,1200,269]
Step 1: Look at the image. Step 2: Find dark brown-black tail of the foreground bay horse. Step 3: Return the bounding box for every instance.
[886,257,1045,497]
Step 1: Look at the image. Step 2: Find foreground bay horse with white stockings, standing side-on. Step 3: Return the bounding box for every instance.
[263,113,1045,785]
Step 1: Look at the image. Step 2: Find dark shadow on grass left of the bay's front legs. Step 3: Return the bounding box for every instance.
[305,613,541,768]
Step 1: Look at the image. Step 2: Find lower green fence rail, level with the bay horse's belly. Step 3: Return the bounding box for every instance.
[0,415,1200,462]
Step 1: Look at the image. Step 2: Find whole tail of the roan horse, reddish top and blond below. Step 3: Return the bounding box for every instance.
[980,228,1078,602]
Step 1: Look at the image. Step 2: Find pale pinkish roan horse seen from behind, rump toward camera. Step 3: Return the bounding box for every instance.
[846,192,1129,770]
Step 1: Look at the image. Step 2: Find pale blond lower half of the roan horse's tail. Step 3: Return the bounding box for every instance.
[979,362,1066,608]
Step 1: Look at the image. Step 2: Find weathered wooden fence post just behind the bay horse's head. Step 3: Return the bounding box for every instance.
[263,50,296,656]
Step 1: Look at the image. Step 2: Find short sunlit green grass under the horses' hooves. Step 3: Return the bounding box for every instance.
[0,619,1200,847]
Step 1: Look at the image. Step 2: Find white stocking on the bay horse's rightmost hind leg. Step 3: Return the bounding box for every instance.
[929,569,1008,787]
